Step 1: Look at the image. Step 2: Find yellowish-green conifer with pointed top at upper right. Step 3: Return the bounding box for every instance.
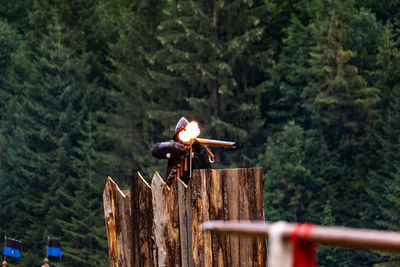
[304,12,379,145]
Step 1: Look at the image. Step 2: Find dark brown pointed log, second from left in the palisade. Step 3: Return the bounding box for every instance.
[130,172,157,267]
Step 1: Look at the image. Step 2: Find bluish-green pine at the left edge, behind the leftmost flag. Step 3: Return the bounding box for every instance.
[0,33,51,262]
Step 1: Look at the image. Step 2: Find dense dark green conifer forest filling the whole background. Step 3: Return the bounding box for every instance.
[0,0,400,267]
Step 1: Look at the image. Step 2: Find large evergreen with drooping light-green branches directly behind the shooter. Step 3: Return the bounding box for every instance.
[151,0,266,168]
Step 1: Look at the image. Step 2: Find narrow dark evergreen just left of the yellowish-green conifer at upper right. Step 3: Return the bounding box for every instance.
[262,17,316,132]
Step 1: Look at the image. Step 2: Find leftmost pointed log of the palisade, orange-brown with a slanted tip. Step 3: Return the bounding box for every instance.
[103,177,132,267]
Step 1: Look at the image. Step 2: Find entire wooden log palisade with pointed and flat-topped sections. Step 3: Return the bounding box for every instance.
[103,168,267,267]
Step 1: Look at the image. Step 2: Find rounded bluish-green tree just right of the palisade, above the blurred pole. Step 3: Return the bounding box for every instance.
[260,122,327,223]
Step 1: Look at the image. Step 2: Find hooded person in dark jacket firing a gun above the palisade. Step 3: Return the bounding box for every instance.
[151,117,211,185]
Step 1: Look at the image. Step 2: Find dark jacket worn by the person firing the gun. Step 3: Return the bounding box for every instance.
[151,140,211,184]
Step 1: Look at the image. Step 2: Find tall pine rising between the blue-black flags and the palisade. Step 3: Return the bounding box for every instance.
[38,15,106,266]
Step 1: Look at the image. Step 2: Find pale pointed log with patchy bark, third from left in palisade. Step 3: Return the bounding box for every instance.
[151,173,181,266]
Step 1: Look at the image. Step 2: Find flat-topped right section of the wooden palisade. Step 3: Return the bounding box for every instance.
[187,168,267,266]
